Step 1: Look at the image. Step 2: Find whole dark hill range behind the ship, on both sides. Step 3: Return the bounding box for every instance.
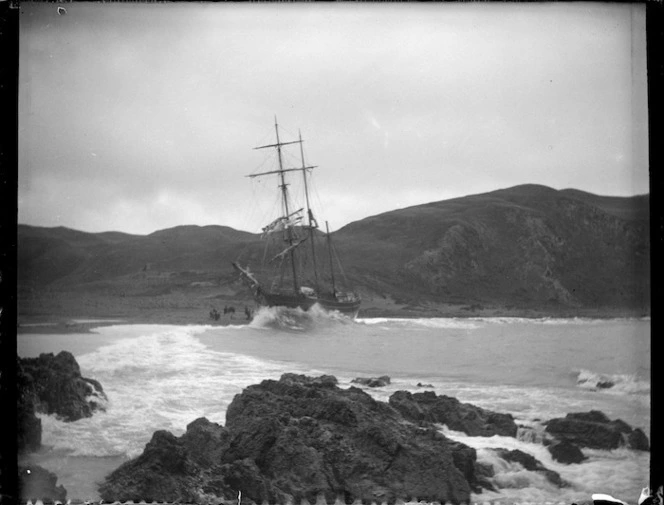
[18,185,650,316]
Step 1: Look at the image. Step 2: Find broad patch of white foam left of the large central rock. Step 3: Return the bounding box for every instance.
[40,325,316,457]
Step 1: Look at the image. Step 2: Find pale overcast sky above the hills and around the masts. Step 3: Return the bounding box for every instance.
[18,2,648,234]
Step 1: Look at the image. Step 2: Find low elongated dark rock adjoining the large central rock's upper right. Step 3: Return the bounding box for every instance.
[389,391,517,437]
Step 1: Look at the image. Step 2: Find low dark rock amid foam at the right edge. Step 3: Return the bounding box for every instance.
[546,410,649,451]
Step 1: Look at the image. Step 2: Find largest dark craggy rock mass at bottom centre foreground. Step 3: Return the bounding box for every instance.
[99,374,496,503]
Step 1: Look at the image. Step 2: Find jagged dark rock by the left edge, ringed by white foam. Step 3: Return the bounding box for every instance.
[17,351,107,424]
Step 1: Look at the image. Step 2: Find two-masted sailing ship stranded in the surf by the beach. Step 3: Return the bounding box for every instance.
[233,117,361,318]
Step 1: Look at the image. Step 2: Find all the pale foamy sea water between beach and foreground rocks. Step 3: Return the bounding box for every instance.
[18,309,650,504]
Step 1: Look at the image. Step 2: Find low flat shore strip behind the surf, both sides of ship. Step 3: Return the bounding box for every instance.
[17,288,650,333]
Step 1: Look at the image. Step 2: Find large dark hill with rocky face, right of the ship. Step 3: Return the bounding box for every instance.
[335,185,650,308]
